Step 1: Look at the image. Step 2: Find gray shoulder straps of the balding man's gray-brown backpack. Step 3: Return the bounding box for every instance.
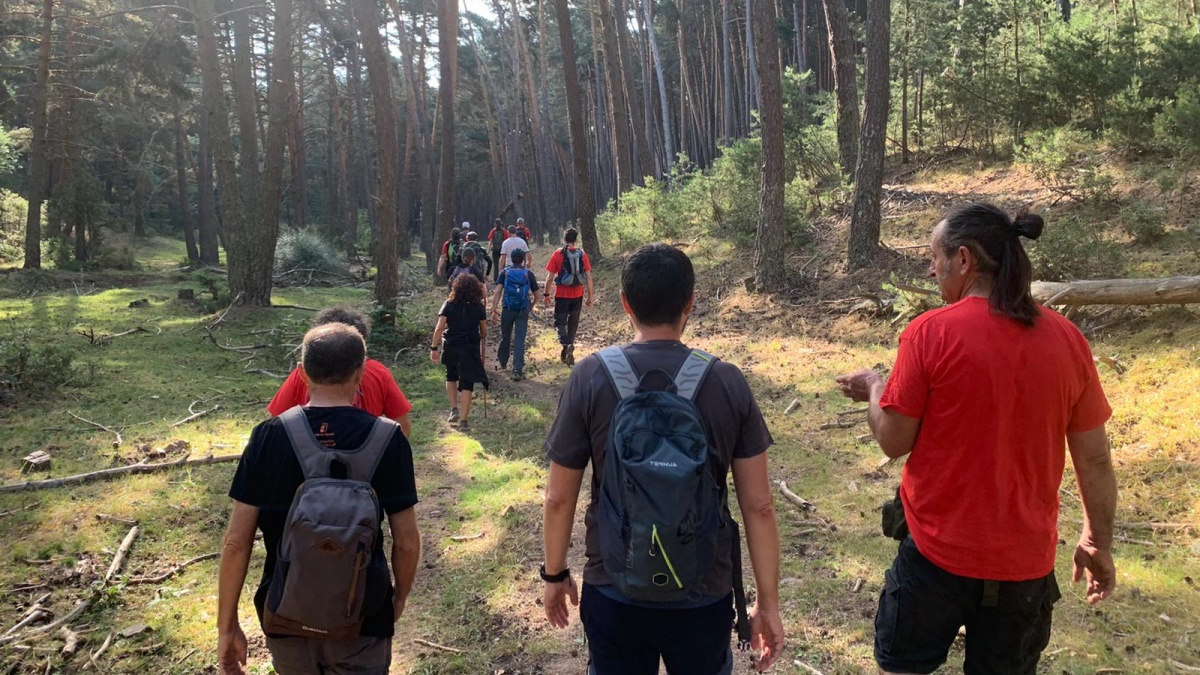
[280,406,400,483]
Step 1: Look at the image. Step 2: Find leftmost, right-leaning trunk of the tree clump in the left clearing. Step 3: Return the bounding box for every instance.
[192,0,247,282]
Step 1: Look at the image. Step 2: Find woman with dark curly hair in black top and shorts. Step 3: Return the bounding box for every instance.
[430,274,488,430]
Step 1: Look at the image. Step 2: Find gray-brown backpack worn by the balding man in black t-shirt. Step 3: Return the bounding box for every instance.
[263,406,398,639]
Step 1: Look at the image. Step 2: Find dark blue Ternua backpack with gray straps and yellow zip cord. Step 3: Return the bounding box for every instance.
[596,347,750,649]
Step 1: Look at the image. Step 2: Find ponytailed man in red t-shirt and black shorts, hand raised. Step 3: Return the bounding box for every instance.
[838,204,1117,675]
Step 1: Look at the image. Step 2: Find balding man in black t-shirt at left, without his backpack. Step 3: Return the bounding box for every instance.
[217,323,421,675]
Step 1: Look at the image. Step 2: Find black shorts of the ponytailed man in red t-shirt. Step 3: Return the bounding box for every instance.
[875,537,1061,675]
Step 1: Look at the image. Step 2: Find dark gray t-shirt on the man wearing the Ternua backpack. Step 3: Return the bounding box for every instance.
[546,340,774,597]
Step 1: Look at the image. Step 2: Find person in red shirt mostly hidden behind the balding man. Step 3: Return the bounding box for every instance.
[266,307,413,437]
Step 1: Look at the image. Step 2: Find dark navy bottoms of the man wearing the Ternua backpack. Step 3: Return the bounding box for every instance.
[580,584,733,675]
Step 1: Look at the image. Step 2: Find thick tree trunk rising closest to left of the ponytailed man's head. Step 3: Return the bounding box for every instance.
[850,0,892,269]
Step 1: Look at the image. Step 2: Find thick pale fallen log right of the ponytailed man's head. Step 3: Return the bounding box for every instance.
[1032,276,1200,305]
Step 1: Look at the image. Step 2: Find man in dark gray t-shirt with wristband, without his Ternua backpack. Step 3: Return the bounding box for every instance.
[541,244,784,675]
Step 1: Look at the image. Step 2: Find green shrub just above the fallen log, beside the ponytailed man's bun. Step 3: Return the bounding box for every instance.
[1027,213,1124,281]
